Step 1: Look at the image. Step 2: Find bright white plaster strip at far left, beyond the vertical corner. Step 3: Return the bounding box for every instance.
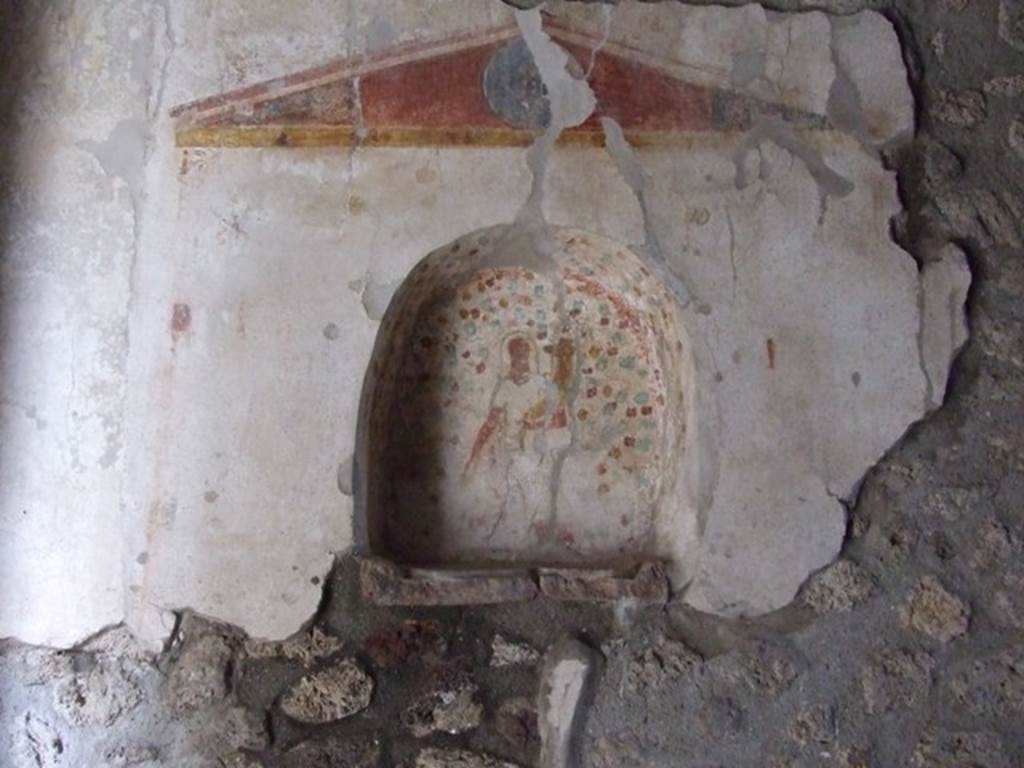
[0,2,159,645]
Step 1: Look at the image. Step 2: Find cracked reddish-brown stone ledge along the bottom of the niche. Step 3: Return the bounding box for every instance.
[359,557,670,606]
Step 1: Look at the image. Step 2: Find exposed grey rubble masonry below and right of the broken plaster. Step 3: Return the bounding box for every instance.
[0,0,1024,768]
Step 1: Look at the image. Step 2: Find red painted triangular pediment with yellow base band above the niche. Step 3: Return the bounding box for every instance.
[172,23,819,147]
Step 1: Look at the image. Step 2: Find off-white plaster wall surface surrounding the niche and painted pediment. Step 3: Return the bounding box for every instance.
[0,0,969,645]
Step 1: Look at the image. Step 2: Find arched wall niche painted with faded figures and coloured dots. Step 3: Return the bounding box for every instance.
[355,225,692,602]
